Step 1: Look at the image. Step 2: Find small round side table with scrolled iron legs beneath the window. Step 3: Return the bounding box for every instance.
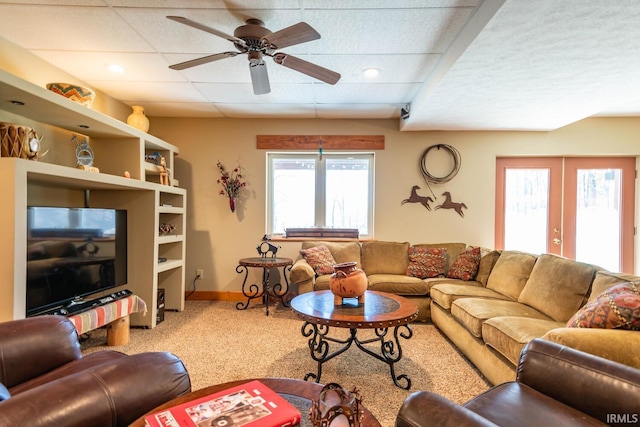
[236,257,292,316]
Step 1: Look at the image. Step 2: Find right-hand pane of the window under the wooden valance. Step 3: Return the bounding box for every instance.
[325,158,371,234]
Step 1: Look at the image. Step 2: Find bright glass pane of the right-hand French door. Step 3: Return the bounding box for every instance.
[576,169,622,271]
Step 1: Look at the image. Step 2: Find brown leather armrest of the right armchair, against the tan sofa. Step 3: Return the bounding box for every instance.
[516,338,640,423]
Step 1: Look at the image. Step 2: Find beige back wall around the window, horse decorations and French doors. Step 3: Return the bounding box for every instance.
[150,117,640,291]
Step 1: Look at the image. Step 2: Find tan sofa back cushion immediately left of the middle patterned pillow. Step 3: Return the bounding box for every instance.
[361,241,410,275]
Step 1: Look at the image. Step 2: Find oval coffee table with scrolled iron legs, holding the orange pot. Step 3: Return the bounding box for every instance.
[291,291,418,390]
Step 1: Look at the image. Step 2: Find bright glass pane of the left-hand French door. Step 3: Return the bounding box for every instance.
[504,169,549,254]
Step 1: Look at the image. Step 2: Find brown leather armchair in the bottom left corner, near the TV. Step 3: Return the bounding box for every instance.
[0,316,191,427]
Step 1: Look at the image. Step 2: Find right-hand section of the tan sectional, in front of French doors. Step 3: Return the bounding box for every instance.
[431,251,640,384]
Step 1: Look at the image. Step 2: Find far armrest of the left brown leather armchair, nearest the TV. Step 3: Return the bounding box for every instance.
[0,316,82,389]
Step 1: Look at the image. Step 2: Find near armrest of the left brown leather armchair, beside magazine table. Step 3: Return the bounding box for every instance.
[0,352,191,427]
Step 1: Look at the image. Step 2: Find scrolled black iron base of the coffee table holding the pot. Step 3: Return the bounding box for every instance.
[302,322,413,390]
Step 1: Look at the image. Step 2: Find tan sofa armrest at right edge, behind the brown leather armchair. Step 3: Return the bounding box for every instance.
[542,328,640,369]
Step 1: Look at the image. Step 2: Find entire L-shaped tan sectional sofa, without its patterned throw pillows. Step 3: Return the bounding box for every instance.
[290,241,640,384]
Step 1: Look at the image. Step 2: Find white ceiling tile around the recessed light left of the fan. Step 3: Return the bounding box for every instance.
[33,50,186,82]
